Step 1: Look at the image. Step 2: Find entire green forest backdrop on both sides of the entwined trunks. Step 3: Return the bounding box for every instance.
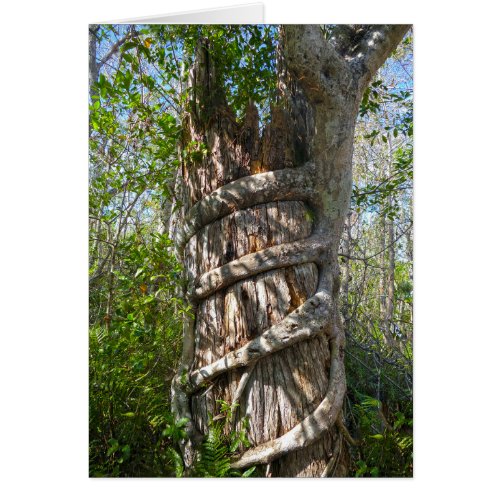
[89,25,413,477]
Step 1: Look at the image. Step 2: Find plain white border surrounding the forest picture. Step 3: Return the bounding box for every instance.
[0,0,500,500]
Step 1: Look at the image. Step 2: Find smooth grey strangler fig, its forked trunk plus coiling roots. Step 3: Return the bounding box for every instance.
[172,26,407,468]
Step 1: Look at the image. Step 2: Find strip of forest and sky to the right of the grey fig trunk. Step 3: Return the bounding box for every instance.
[341,32,413,477]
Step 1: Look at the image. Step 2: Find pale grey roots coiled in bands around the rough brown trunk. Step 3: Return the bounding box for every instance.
[172,163,346,469]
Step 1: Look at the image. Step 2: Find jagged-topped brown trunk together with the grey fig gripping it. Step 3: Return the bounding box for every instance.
[172,25,409,477]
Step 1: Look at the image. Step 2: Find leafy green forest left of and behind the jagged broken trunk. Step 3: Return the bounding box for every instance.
[89,25,276,476]
